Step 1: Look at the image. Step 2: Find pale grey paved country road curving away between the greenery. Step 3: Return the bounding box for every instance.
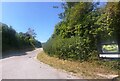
[0,48,81,79]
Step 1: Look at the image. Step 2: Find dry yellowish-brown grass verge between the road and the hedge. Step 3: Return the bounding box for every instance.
[37,52,118,79]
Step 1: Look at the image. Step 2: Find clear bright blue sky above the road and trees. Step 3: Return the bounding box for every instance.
[0,2,63,42]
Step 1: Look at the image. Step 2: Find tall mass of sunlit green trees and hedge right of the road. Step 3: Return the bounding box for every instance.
[43,2,120,61]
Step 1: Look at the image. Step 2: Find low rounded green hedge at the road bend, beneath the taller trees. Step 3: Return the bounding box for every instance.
[43,37,97,61]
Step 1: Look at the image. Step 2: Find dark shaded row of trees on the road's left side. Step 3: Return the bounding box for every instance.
[0,23,42,52]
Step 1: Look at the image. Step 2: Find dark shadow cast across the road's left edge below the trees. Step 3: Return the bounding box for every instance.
[2,49,33,59]
